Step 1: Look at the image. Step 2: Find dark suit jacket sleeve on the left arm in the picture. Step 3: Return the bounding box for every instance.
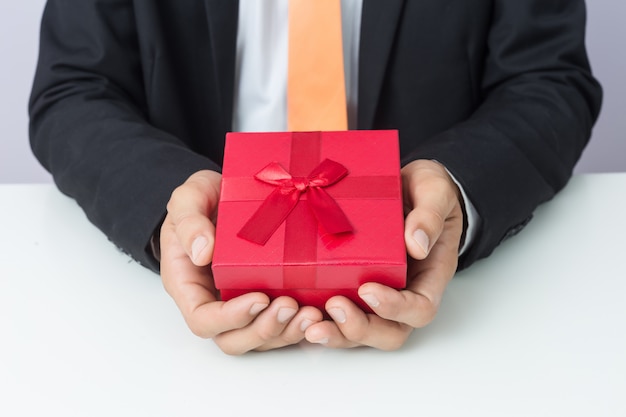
[29,0,219,270]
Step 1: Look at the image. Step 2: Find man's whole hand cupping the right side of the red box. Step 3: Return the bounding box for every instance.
[305,160,463,350]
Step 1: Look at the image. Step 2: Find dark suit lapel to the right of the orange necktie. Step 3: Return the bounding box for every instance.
[357,0,404,129]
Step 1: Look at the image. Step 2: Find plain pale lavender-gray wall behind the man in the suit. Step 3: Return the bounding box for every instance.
[0,0,626,183]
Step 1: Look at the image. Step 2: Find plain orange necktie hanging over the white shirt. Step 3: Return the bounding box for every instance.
[287,0,348,131]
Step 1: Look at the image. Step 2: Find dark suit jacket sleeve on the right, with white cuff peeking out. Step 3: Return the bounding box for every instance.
[405,0,601,268]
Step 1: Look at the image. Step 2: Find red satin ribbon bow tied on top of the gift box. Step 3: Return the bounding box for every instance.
[237,159,352,245]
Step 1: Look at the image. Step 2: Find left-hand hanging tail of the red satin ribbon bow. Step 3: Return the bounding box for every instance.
[237,188,300,245]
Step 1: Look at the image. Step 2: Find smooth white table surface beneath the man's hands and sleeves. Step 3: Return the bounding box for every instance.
[0,174,626,417]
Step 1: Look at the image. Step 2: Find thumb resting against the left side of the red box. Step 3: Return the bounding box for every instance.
[164,170,221,265]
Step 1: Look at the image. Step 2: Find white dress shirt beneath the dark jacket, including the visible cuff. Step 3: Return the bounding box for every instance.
[232,0,479,253]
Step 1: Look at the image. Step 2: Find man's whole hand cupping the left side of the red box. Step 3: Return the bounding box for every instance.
[161,170,322,355]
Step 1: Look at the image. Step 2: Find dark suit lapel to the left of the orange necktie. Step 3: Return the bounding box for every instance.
[204,0,239,131]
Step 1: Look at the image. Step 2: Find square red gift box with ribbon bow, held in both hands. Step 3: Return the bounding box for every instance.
[212,131,406,311]
